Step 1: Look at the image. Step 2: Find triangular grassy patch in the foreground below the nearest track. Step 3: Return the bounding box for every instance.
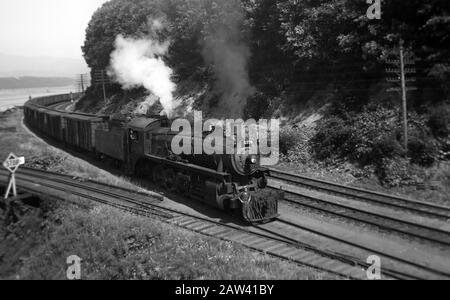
[8,205,333,280]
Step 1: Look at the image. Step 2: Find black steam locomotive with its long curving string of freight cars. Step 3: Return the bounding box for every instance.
[24,94,279,223]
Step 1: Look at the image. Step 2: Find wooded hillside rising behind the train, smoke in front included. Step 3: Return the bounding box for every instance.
[77,0,450,192]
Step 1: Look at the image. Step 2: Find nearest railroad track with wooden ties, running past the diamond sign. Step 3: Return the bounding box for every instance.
[0,169,450,279]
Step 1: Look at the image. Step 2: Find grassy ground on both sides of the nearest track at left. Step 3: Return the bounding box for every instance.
[0,109,335,279]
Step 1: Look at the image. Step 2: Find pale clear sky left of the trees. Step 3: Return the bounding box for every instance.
[0,0,107,59]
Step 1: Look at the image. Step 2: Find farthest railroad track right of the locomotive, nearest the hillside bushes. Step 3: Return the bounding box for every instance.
[270,168,450,221]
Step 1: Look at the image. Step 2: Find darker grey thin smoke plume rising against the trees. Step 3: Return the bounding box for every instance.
[203,6,255,118]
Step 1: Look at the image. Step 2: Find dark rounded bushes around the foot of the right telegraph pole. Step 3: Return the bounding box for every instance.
[312,107,442,171]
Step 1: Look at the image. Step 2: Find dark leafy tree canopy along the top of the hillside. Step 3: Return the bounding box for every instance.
[83,0,450,104]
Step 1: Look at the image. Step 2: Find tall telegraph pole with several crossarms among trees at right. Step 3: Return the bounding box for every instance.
[386,40,417,150]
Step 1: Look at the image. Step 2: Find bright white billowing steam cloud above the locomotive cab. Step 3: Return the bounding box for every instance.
[109,32,177,117]
